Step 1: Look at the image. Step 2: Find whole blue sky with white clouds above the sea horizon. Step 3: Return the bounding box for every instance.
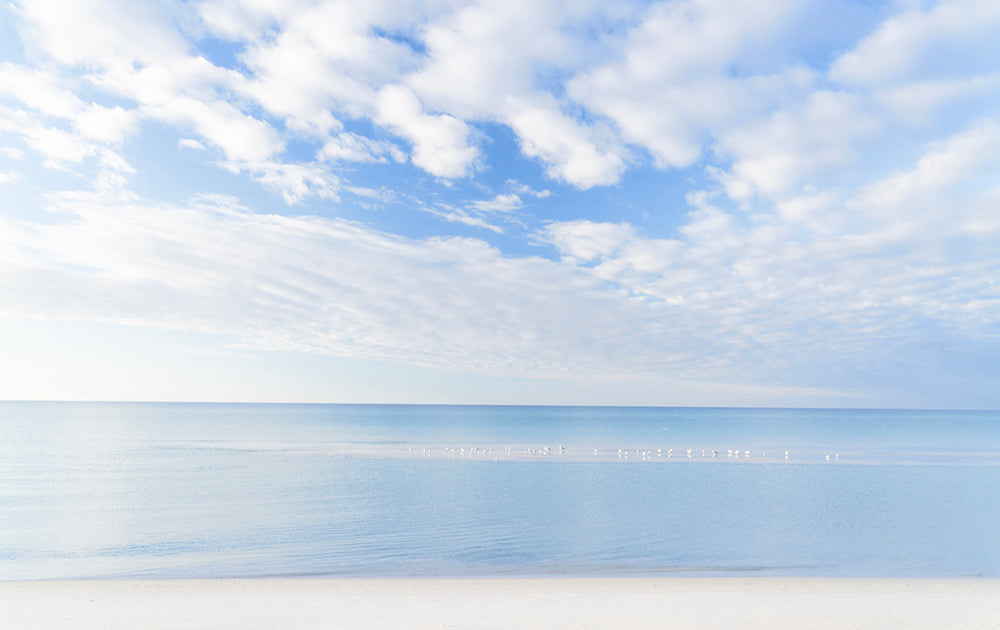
[0,0,1000,409]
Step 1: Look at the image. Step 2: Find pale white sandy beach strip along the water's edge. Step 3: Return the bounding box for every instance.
[0,578,1000,630]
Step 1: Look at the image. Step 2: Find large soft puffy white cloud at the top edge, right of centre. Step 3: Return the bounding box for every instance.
[568,0,812,168]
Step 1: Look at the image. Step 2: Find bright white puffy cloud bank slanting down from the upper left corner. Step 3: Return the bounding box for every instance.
[8,0,339,203]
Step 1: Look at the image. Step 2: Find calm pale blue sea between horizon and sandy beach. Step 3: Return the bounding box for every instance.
[0,402,1000,580]
